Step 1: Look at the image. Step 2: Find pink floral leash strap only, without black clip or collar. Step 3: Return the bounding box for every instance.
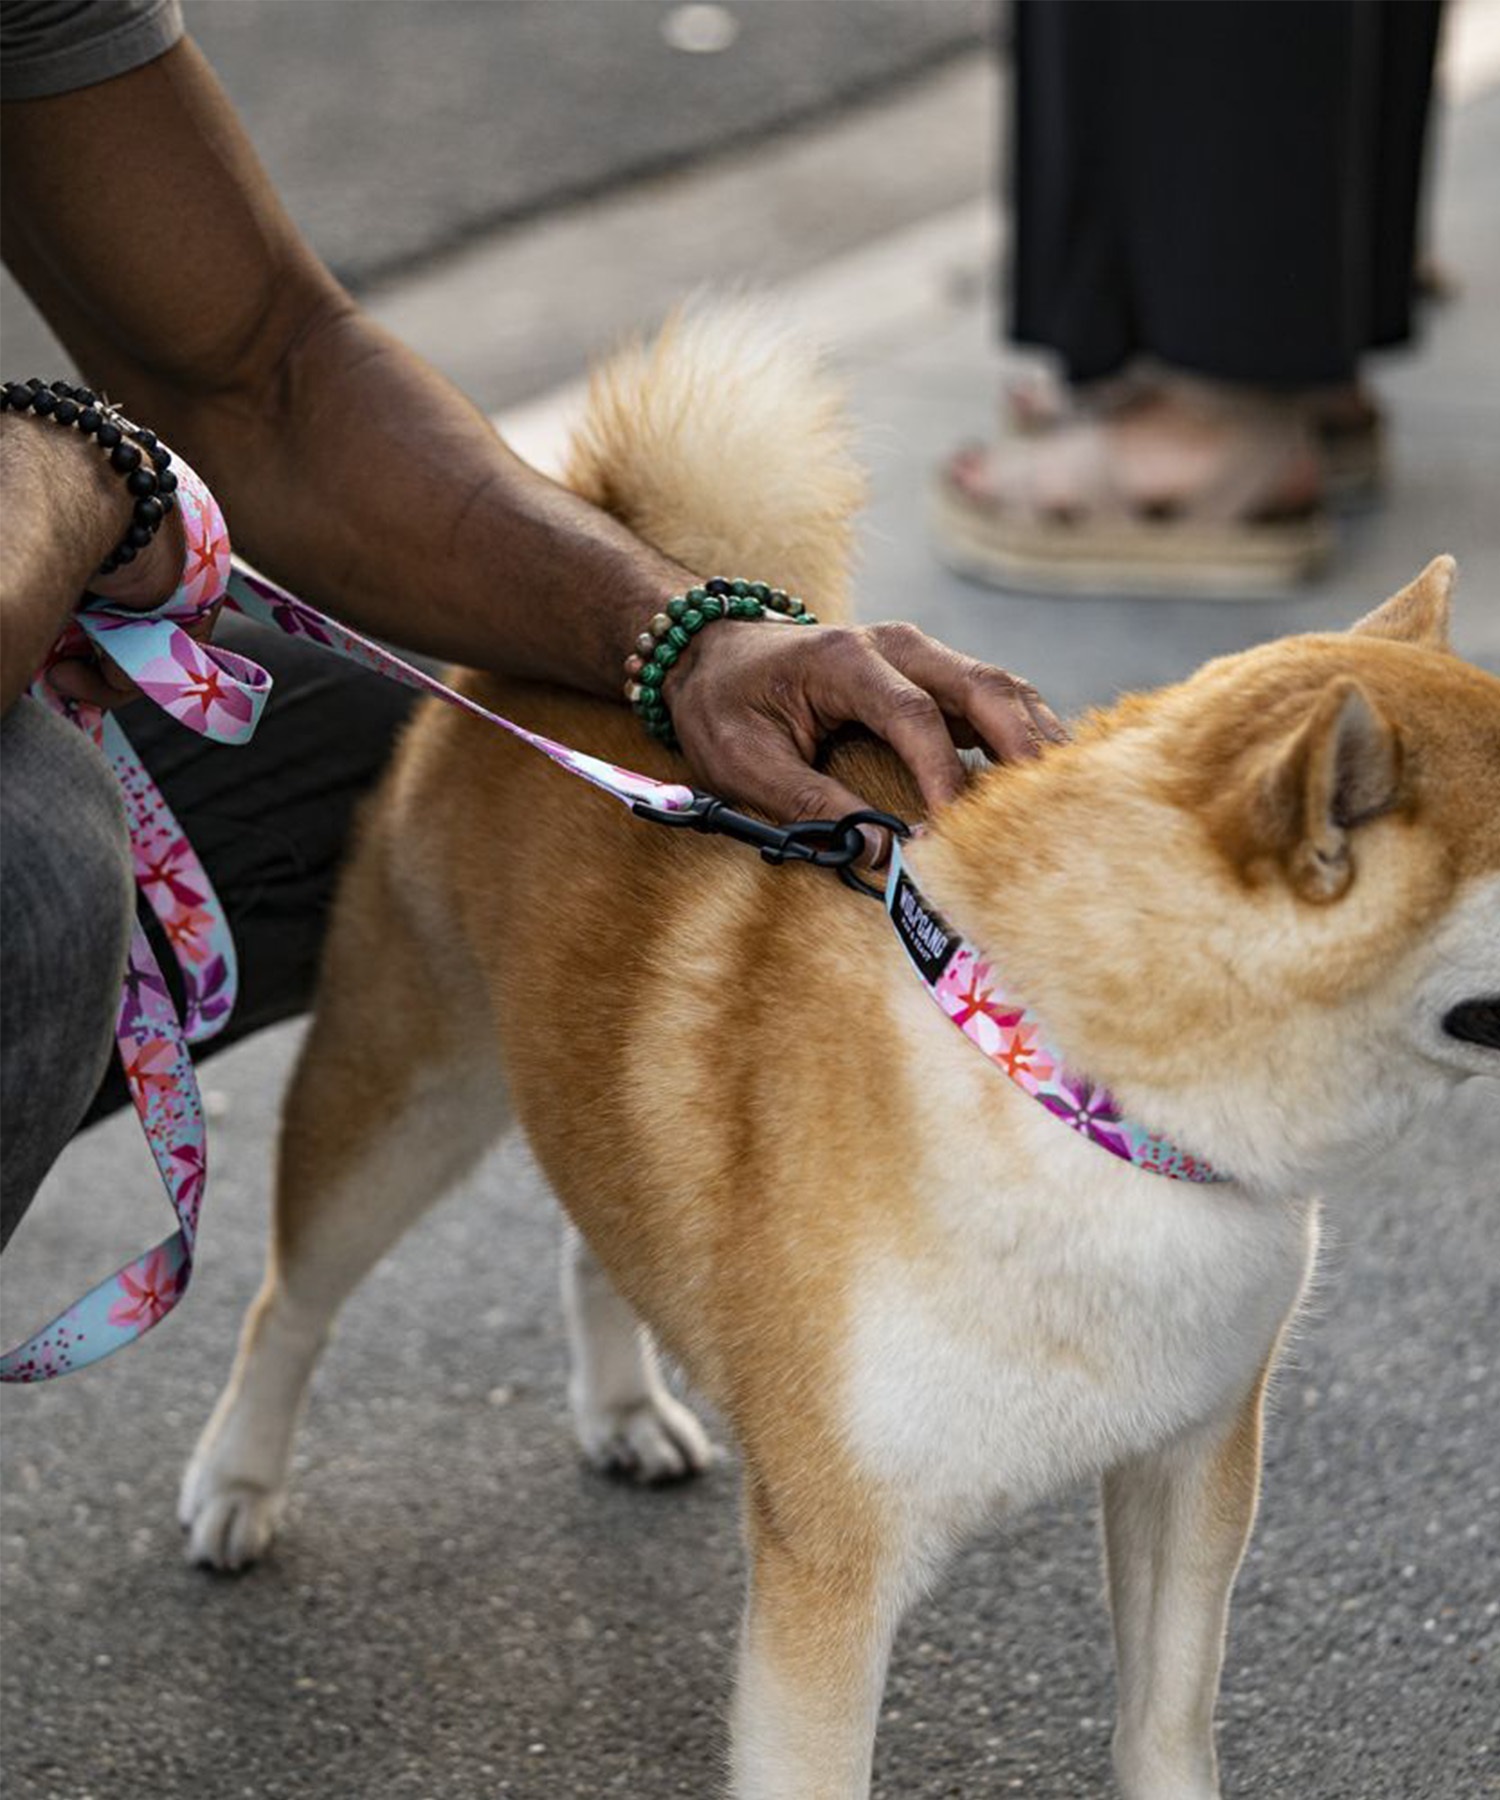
[0,457,702,1382]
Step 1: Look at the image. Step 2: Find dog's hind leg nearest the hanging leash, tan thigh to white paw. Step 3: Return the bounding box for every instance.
[180,841,508,1570]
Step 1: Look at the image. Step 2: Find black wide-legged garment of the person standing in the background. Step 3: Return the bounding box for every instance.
[1010,0,1442,387]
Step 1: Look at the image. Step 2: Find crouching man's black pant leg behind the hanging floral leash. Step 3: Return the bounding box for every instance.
[85,614,416,1123]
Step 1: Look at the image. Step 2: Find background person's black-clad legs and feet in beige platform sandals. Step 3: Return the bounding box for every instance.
[933,0,1441,598]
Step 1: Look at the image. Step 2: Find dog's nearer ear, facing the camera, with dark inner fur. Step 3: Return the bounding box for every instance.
[1255,675,1401,902]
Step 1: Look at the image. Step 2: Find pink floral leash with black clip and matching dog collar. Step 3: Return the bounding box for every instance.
[0,459,1228,1382]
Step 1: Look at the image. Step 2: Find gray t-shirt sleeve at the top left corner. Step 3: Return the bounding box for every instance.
[0,0,182,101]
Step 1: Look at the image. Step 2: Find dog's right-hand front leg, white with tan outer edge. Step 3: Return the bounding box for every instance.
[1104,1373,1266,1800]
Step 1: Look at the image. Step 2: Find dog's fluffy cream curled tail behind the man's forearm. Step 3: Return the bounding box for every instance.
[564,299,864,619]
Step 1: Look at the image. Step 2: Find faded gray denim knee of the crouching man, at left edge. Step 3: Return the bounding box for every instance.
[0,698,135,1246]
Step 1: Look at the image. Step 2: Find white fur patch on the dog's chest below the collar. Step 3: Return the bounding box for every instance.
[845,1069,1316,1523]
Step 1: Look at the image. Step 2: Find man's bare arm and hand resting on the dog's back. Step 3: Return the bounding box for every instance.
[4,41,1046,812]
